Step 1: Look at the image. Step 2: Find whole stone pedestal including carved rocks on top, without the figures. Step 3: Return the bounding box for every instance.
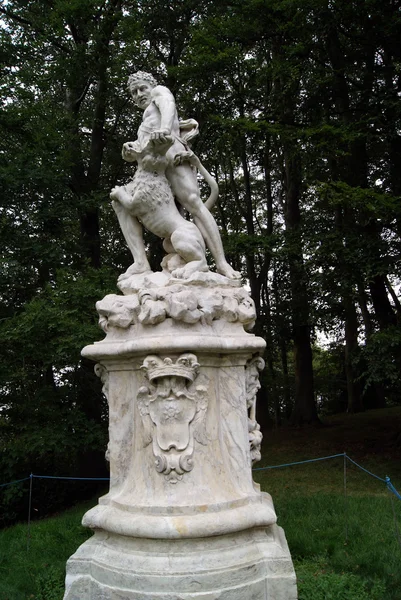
[64,274,297,600]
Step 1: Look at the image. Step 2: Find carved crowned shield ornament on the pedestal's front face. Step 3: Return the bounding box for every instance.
[137,353,208,484]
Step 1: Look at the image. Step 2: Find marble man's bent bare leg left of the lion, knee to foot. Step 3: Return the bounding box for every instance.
[110,188,152,279]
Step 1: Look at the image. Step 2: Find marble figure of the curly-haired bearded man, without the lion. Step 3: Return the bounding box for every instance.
[112,71,240,279]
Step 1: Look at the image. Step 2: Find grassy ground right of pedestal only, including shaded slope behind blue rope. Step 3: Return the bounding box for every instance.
[254,406,401,600]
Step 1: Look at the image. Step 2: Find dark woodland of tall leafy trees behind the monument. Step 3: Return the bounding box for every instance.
[0,0,401,524]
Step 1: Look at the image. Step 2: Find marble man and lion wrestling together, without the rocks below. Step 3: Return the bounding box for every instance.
[111,71,240,279]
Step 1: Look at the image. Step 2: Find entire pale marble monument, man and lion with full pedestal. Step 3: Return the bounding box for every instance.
[64,72,297,600]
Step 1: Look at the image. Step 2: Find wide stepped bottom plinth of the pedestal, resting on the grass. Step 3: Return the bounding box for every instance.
[64,525,297,600]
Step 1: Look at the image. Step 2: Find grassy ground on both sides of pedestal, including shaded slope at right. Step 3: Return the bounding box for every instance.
[0,407,401,600]
